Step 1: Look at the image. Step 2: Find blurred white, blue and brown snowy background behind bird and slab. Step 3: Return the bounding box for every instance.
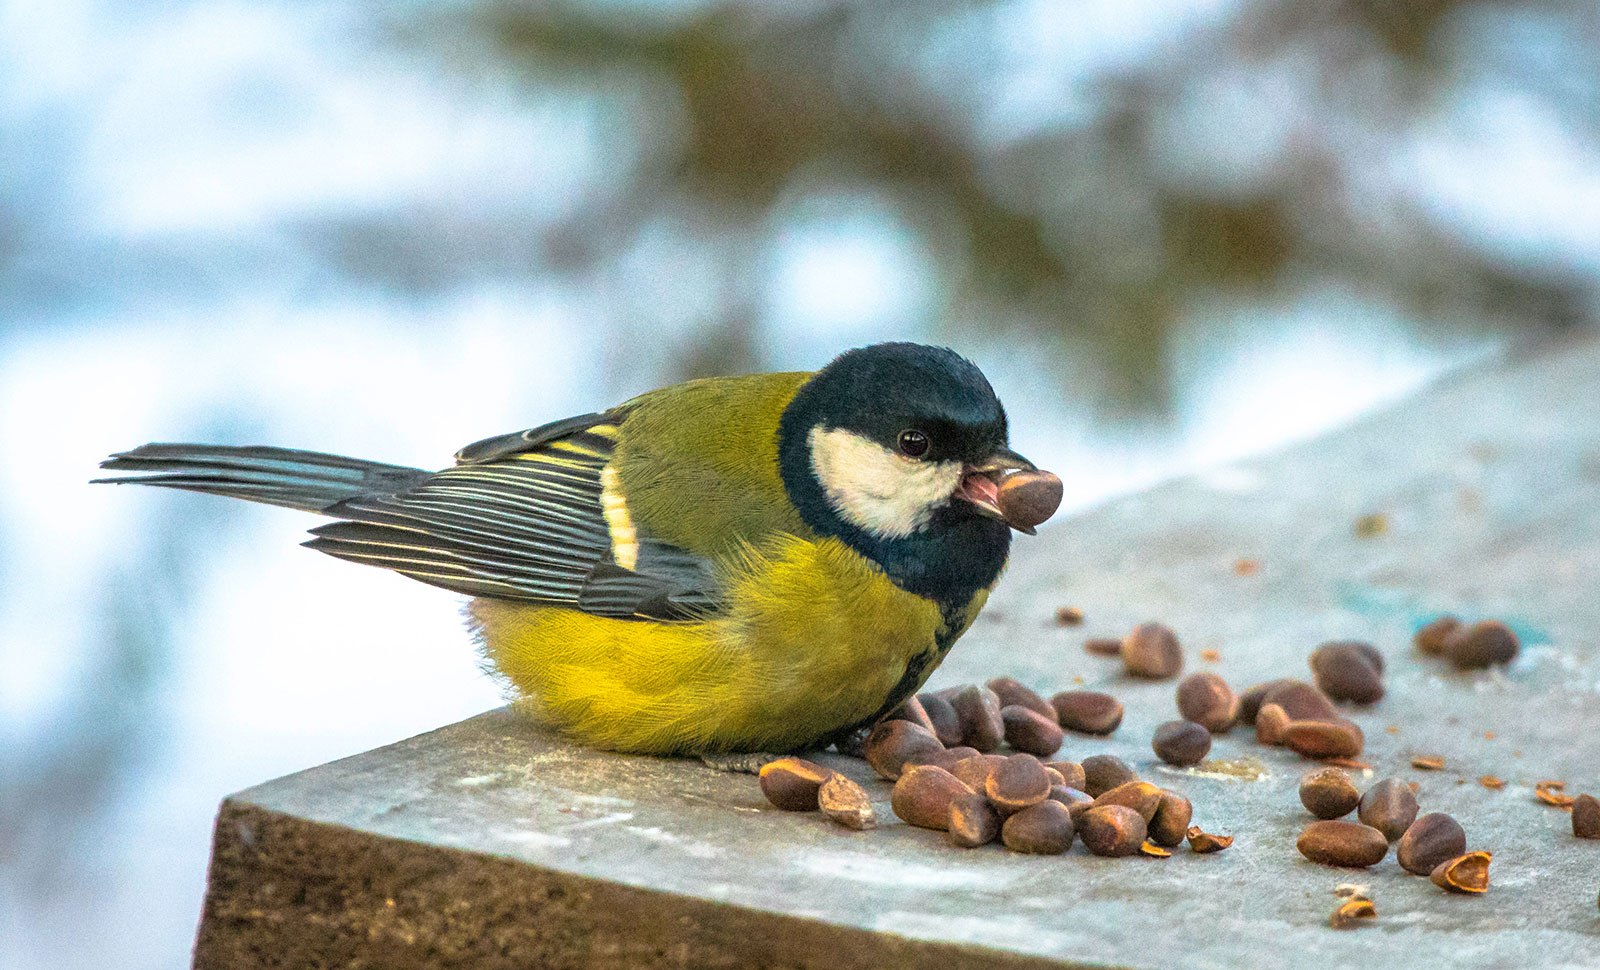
[0,0,1600,970]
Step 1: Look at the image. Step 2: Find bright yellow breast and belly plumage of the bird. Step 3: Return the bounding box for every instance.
[470,536,953,754]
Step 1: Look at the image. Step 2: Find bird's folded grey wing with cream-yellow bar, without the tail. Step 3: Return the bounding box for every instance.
[306,411,722,619]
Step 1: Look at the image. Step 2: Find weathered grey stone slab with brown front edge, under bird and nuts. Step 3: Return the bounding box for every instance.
[195,338,1600,970]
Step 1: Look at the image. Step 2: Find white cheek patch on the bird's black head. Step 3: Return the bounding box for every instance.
[810,427,963,539]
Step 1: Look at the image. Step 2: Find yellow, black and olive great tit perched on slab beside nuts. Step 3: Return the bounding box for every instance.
[98,343,1059,756]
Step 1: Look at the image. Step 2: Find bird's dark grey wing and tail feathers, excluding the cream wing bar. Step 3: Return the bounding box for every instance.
[98,411,720,621]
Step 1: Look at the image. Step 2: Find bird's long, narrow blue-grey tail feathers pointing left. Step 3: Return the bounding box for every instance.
[94,445,432,512]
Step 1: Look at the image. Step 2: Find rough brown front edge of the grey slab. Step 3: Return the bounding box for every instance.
[194,799,1106,970]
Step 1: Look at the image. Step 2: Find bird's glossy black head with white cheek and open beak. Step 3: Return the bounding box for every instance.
[778,343,1032,607]
